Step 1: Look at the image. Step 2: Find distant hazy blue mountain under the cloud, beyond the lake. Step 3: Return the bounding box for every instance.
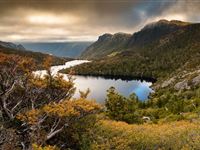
[21,42,91,58]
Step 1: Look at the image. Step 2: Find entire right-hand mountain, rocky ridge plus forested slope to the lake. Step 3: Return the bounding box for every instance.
[64,20,200,79]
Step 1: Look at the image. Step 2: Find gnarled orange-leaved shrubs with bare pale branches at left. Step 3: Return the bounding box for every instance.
[0,55,101,150]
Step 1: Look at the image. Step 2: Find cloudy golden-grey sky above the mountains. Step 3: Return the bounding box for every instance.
[0,0,200,42]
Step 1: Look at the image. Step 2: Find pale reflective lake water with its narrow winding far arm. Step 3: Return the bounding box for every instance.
[34,60,153,103]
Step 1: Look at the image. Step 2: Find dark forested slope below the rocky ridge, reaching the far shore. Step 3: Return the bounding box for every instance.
[63,22,200,78]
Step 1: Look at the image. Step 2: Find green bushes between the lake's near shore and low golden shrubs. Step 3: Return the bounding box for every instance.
[105,87,200,123]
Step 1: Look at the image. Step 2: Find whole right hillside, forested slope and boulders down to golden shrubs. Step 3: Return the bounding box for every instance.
[57,22,200,149]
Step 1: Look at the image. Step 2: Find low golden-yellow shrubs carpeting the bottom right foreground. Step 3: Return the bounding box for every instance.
[88,120,200,150]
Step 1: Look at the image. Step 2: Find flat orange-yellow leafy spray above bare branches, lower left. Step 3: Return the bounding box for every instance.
[17,99,101,124]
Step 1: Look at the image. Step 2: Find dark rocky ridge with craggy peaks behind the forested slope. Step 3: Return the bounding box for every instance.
[81,20,191,59]
